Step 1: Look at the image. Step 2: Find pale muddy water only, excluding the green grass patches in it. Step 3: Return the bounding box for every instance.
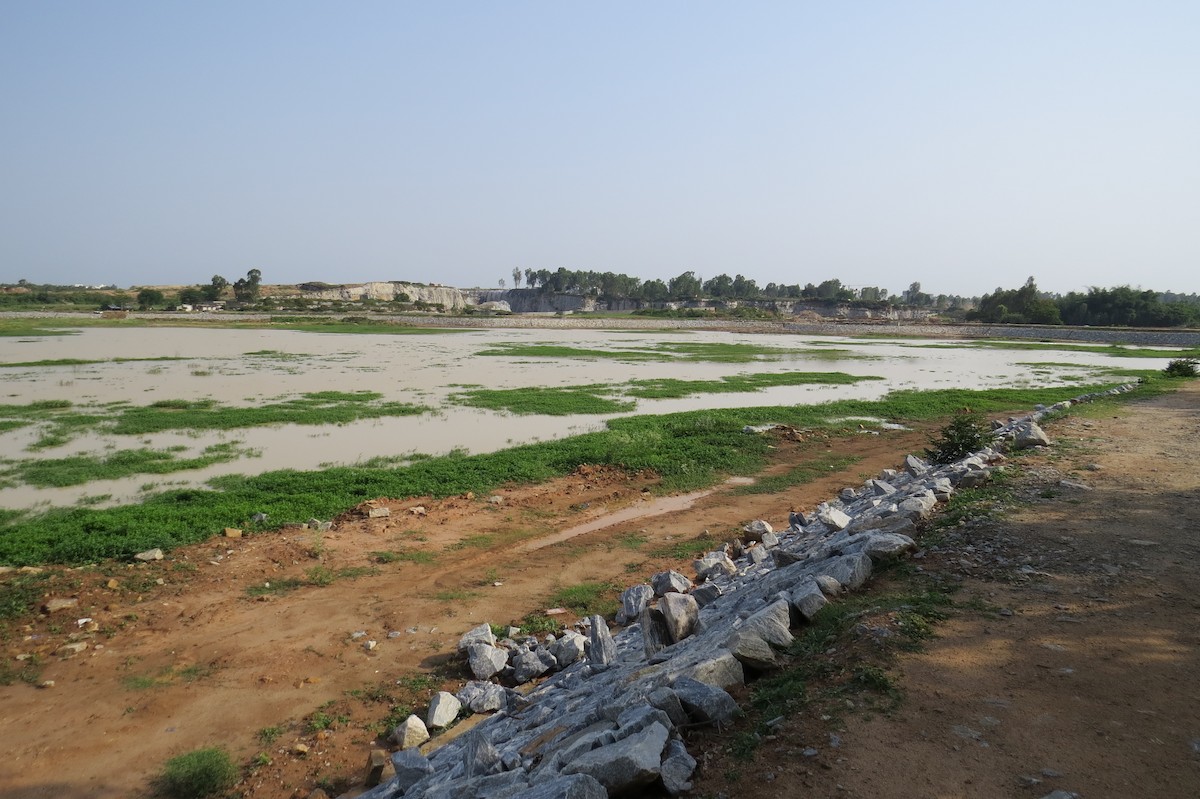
[0,328,1160,507]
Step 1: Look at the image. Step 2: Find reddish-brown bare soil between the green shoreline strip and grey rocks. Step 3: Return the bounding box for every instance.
[0,419,926,799]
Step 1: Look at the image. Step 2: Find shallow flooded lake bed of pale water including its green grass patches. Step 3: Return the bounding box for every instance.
[0,328,1163,509]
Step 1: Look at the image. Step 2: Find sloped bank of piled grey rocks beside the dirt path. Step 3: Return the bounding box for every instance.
[350,385,1134,799]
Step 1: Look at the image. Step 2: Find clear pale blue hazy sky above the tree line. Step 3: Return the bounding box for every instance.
[0,0,1200,296]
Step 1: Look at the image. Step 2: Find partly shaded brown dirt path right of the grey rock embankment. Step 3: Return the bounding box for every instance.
[696,382,1200,799]
